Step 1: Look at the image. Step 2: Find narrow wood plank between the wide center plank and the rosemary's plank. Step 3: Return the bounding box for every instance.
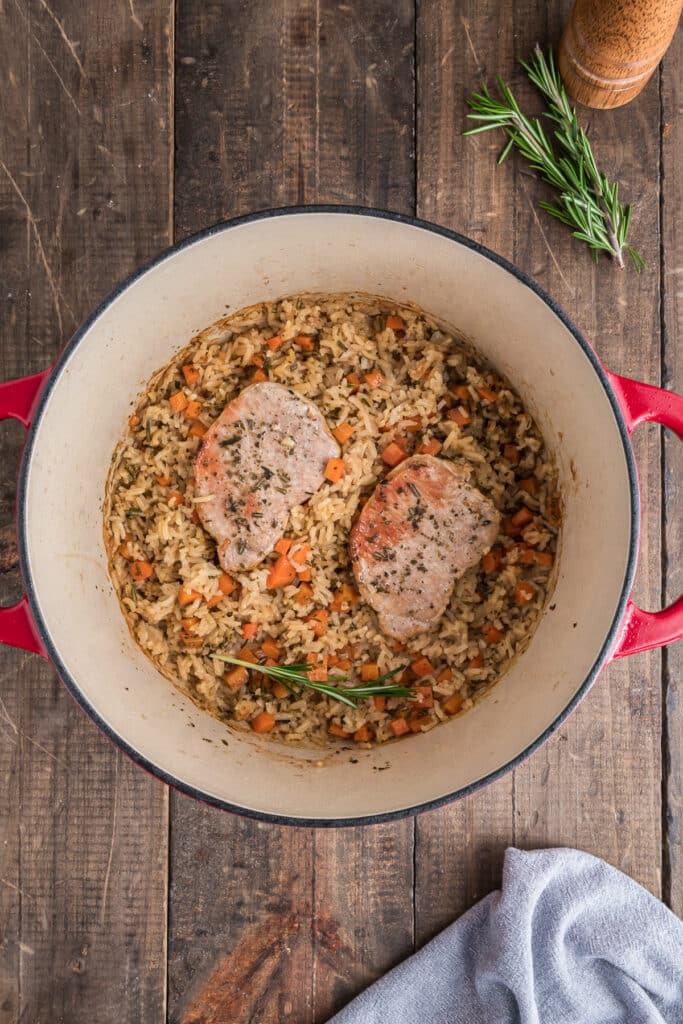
[415,0,514,944]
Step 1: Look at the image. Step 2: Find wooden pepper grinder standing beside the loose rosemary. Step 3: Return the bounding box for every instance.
[558,0,683,108]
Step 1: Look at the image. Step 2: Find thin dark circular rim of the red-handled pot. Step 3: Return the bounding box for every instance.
[16,204,640,828]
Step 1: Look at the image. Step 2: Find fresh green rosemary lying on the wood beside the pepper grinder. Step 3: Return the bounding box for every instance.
[464,44,645,272]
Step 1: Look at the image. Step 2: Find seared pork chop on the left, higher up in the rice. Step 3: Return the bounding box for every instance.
[195,381,339,572]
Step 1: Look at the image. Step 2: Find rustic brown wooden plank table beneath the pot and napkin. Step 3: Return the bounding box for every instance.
[0,0,683,1024]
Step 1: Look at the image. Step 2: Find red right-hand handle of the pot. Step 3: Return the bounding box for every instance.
[607,372,683,658]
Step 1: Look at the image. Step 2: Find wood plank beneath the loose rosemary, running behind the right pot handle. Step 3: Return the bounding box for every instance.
[511,0,661,895]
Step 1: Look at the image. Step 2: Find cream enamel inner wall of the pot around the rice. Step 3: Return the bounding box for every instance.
[18,212,631,819]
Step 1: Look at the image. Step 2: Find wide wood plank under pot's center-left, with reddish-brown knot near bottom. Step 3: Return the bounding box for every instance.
[169,0,414,1024]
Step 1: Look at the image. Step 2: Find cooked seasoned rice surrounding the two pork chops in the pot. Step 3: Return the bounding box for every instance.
[104,295,559,745]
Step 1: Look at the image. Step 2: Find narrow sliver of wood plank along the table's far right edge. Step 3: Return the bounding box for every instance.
[661,32,683,916]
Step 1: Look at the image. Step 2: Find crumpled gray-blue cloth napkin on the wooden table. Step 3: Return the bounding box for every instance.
[329,850,683,1024]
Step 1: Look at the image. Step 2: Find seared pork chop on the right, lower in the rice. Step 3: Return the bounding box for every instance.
[350,455,501,640]
